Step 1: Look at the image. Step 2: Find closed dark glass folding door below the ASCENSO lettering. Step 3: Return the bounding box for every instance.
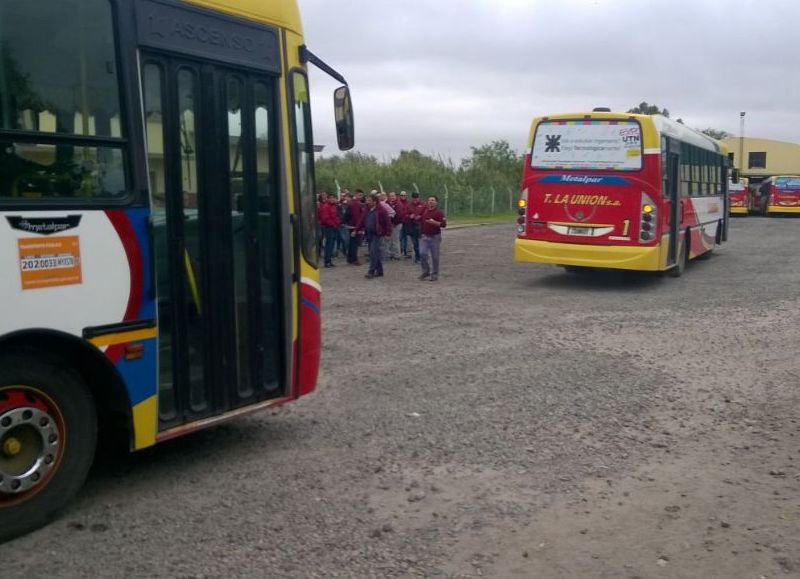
[142,53,285,429]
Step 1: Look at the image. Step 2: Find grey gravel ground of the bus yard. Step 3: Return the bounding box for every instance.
[0,217,800,579]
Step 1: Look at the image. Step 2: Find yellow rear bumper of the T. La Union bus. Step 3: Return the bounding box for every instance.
[514,239,664,271]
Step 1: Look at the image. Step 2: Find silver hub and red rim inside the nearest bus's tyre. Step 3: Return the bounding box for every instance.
[0,391,61,495]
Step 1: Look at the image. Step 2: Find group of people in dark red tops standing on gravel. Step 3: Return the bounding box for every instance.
[318,189,447,281]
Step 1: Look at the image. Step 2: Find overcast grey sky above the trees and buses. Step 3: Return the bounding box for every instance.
[300,0,800,161]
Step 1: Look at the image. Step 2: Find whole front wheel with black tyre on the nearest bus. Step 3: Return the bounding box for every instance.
[0,354,97,542]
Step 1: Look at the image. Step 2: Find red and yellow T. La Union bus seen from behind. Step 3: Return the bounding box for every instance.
[514,112,728,276]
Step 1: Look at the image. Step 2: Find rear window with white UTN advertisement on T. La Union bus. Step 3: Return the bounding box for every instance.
[531,119,642,171]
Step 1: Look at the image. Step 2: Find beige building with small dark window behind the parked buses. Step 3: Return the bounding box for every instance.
[722,137,800,183]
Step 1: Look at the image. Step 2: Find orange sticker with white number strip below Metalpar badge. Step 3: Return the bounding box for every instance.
[17,235,83,290]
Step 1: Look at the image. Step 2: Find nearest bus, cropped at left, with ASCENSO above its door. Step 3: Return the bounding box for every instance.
[0,0,353,539]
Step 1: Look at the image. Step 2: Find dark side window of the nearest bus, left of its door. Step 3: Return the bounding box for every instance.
[0,0,127,201]
